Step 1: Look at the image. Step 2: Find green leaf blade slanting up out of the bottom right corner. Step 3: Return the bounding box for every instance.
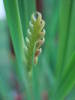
[56,53,75,100]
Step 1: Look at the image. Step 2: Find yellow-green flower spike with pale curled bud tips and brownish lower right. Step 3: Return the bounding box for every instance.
[25,12,45,71]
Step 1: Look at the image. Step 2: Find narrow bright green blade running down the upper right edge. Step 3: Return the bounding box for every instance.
[65,0,75,64]
